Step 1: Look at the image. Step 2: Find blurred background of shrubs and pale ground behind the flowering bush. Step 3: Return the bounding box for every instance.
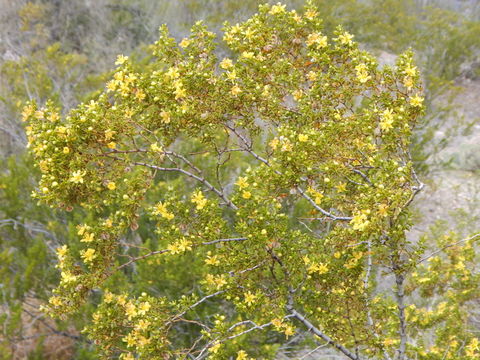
[0,0,480,360]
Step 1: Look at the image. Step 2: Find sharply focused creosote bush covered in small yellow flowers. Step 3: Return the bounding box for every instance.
[23,4,480,360]
